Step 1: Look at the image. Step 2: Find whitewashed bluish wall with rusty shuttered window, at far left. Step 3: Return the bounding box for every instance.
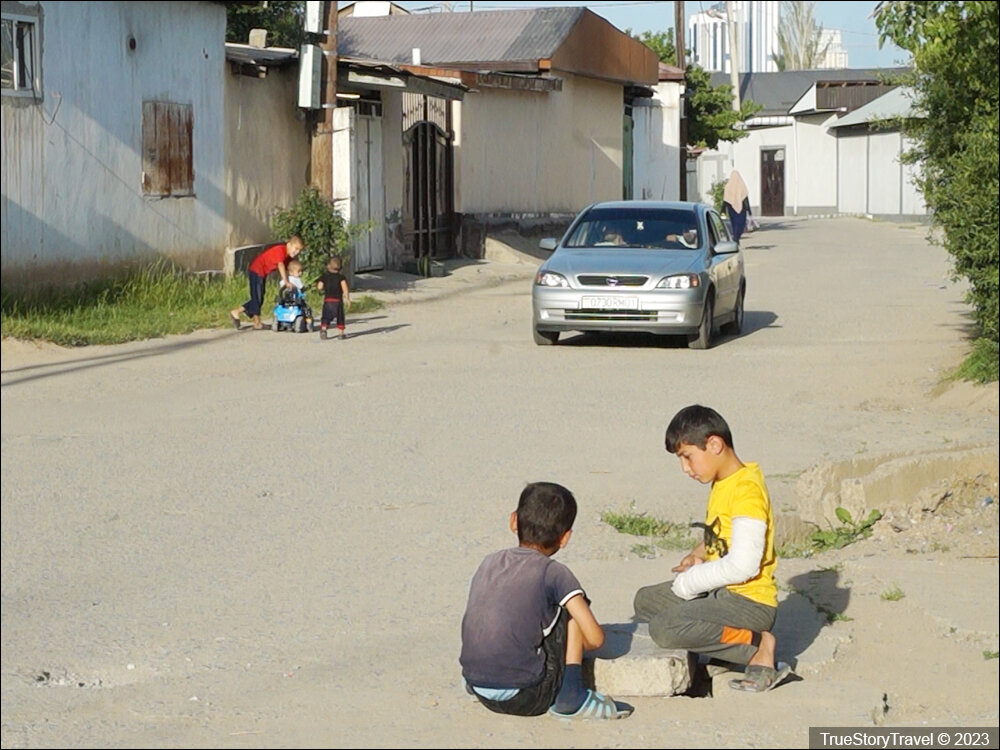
[0,0,226,283]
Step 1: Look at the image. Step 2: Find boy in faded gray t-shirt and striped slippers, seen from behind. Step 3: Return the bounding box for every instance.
[459,482,632,719]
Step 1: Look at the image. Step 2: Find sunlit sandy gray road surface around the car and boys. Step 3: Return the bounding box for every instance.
[0,218,1000,748]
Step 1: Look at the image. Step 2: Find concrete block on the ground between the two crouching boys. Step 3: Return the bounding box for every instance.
[584,622,697,698]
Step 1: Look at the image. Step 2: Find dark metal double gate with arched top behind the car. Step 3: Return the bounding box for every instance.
[403,94,454,275]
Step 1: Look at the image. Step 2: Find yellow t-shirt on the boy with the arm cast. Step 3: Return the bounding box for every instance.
[705,463,778,607]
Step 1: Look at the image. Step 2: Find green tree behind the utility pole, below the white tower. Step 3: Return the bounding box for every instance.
[684,65,761,148]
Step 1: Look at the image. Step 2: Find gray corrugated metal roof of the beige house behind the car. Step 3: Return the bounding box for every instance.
[337,7,586,70]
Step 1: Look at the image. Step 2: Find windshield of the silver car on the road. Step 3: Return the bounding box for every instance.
[564,208,701,250]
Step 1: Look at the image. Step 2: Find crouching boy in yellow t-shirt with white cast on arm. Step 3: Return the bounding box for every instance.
[634,404,791,692]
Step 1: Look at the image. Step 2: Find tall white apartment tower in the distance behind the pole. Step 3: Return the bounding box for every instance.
[688,0,781,73]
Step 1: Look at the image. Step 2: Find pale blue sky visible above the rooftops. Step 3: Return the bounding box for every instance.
[384,0,909,68]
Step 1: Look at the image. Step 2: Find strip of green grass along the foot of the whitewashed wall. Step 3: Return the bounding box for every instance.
[0,263,382,346]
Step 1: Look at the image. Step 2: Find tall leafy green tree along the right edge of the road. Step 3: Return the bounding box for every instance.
[875,2,1000,381]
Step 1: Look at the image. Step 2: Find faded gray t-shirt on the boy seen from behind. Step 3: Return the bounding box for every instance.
[459,547,583,688]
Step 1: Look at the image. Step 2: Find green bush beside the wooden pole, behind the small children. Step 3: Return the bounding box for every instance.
[271,186,371,279]
